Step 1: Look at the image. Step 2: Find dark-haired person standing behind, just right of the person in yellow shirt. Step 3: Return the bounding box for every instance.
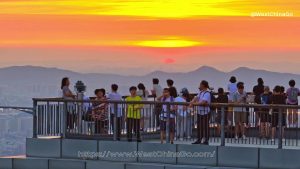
[137,83,150,131]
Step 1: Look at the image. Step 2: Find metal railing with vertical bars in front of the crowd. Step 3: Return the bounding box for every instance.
[33,98,300,149]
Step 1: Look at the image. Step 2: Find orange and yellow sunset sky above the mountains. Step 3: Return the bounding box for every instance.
[0,0,300,74]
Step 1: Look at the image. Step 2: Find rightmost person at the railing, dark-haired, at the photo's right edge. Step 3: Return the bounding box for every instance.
[286,80,300,127]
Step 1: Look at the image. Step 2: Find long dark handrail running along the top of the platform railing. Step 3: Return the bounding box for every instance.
[33,98,300,109]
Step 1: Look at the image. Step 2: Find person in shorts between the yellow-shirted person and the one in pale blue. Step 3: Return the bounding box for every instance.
[159,88,175,144]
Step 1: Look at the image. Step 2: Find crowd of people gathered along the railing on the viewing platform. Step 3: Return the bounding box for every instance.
[61,76,300,144]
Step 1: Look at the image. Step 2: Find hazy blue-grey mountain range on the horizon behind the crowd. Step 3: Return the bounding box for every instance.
[0,66,300,97]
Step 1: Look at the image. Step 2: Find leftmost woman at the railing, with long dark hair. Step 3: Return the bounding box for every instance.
[61,77,76,129]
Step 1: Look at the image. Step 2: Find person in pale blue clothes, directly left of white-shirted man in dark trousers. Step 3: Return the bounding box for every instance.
[175,88,192,141]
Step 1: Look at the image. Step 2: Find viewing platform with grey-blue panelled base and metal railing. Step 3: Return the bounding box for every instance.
[0,99,300,169]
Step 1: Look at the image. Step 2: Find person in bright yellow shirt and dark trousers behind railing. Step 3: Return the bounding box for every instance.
[125,86,143,142]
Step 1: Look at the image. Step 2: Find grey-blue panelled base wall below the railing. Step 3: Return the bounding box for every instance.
[23,139,300,169]
